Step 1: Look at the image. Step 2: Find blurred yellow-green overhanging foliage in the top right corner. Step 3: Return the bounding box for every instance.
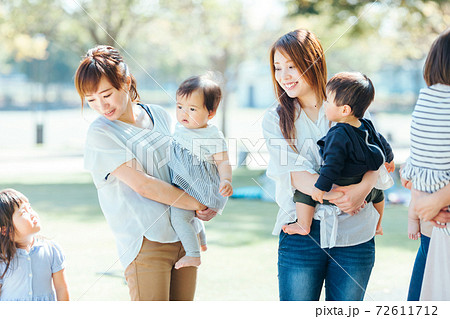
[285,0,450,60]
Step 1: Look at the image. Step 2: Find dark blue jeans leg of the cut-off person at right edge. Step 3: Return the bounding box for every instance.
[408,234,430,301]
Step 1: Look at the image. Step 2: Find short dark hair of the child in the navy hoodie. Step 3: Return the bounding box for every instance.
[327,72,375,119]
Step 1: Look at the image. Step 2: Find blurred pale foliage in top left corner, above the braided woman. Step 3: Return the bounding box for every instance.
[0,0,156,72]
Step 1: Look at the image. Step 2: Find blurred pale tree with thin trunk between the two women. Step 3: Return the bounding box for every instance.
[142,0,278,134]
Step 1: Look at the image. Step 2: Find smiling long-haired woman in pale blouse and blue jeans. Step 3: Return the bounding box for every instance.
[262,30,378,300]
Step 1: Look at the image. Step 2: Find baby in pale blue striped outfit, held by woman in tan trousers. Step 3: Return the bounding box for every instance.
[169,75,233,269]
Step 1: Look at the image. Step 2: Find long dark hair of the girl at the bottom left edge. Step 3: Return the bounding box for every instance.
[0,189,28,278]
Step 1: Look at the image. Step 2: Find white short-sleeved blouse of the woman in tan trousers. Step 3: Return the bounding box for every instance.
[84,105,203,268]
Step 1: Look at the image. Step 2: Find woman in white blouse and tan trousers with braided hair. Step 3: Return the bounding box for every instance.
[75,46,216,300]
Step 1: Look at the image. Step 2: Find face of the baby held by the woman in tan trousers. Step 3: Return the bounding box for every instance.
[177,90,214,129]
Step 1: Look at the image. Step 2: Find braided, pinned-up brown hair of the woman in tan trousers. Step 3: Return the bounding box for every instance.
[74,45,140,107]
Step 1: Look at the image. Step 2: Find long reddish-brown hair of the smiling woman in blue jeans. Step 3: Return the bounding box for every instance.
[270,29,327,151]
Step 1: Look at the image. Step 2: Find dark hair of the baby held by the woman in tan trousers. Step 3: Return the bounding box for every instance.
[176,74,222,112]
